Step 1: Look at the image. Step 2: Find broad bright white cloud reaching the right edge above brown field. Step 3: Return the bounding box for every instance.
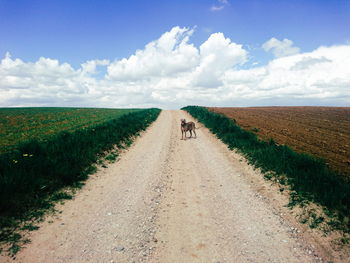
[225,46,350,106]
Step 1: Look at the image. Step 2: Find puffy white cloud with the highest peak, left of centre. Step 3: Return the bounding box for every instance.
[108,27,199,80]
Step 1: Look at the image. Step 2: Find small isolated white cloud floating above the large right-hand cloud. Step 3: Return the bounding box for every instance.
[262,37,300,57]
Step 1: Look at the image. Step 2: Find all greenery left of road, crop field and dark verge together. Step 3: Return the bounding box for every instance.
[0,108,160,254]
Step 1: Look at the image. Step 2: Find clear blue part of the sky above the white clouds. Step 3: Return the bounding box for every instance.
[0,0,350,66]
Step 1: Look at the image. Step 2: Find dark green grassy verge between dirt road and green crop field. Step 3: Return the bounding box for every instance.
[0,109,160,255]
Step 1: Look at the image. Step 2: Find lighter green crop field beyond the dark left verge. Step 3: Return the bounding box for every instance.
[0,108,139,154]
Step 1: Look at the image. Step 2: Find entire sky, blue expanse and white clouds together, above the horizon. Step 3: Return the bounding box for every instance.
[0,0,350,109]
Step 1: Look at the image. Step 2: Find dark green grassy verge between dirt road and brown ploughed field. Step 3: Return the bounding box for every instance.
[183,106,350,234]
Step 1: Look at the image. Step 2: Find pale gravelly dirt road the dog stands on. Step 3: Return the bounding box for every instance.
[4,111,321,263]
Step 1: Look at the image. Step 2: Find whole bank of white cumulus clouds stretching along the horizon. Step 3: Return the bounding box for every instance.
[0,27,350,108]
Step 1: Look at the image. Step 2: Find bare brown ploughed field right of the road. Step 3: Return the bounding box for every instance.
[209,107,350,178]
